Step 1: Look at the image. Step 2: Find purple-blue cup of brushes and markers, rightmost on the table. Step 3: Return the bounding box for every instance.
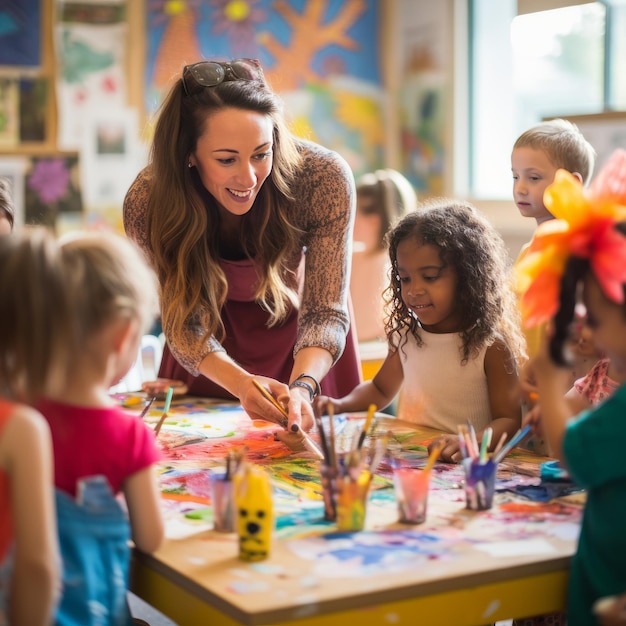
[459,423,530,511]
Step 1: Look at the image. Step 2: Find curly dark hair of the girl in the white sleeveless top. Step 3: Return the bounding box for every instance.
[384,198,526,365]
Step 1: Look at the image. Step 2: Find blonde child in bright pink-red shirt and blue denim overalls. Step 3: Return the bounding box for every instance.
[37,232,163,625]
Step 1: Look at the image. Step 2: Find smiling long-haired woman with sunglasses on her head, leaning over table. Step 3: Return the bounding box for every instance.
[124,59,360,429]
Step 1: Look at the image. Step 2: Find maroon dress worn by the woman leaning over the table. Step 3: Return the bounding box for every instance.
[159,254,361,398]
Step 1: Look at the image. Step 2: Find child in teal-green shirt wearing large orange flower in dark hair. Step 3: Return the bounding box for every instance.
[518,162,626,626]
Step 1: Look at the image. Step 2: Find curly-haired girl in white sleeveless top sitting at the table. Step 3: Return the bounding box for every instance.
[319,199,524,462]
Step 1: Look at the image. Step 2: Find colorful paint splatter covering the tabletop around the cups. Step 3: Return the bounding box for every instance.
[119,394,582,576]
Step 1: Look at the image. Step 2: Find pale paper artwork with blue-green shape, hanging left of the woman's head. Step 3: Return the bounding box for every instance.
[55,0,127,150]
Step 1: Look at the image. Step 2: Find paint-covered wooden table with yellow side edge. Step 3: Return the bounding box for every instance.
[124,394,582,626]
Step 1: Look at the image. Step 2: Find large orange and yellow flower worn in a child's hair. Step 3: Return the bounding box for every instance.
[517,150,626,327]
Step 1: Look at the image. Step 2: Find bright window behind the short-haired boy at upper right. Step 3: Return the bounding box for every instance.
[468,0,626,199]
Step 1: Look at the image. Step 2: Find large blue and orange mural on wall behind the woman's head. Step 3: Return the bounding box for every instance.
[146,0,384,173]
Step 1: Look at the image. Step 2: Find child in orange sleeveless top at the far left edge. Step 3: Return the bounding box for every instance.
[0,229,65,626]
